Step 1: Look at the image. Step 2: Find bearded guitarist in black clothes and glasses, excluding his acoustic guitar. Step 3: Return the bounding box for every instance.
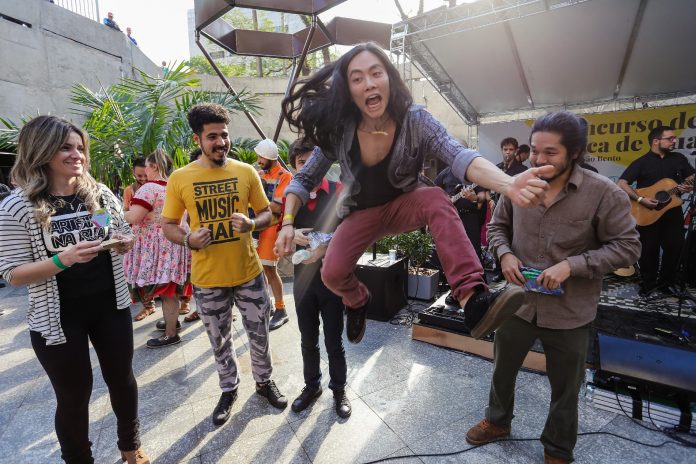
[618,126,694,296]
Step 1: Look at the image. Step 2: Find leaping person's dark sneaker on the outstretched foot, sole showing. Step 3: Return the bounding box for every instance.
[464,285,524,339]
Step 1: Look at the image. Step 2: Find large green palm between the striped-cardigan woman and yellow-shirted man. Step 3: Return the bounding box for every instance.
[70,63,259,187]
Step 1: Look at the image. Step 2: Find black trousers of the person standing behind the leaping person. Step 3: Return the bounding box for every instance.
[293,266,347,390]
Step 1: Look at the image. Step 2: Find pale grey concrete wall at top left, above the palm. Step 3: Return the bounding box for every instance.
[0,0,160,122]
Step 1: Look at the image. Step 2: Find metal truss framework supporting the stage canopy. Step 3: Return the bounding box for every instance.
[391,0,696,125]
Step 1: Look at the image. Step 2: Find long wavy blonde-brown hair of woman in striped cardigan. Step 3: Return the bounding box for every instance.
[11,116,100,228]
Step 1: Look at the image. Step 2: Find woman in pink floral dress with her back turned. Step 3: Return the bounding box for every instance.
[124,149,192,348]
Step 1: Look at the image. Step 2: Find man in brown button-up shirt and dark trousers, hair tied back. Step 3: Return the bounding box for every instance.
[466,112,640,463]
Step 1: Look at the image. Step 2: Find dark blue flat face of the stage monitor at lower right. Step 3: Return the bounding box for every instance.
[598,333,696,393]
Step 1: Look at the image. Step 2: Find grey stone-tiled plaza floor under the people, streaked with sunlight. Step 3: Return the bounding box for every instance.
[0,285,696,464]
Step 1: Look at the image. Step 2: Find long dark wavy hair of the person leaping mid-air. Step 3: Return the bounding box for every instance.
[282,42,413,150]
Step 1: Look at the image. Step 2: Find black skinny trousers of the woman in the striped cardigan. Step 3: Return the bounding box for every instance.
[29,295,140,464]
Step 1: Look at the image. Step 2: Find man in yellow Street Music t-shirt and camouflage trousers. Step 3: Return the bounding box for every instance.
[162,103,288,425]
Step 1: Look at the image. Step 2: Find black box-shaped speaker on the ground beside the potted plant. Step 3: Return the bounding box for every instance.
[355,254,408,321]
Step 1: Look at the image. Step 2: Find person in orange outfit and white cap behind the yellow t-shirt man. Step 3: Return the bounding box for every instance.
[254,139,292,330]
